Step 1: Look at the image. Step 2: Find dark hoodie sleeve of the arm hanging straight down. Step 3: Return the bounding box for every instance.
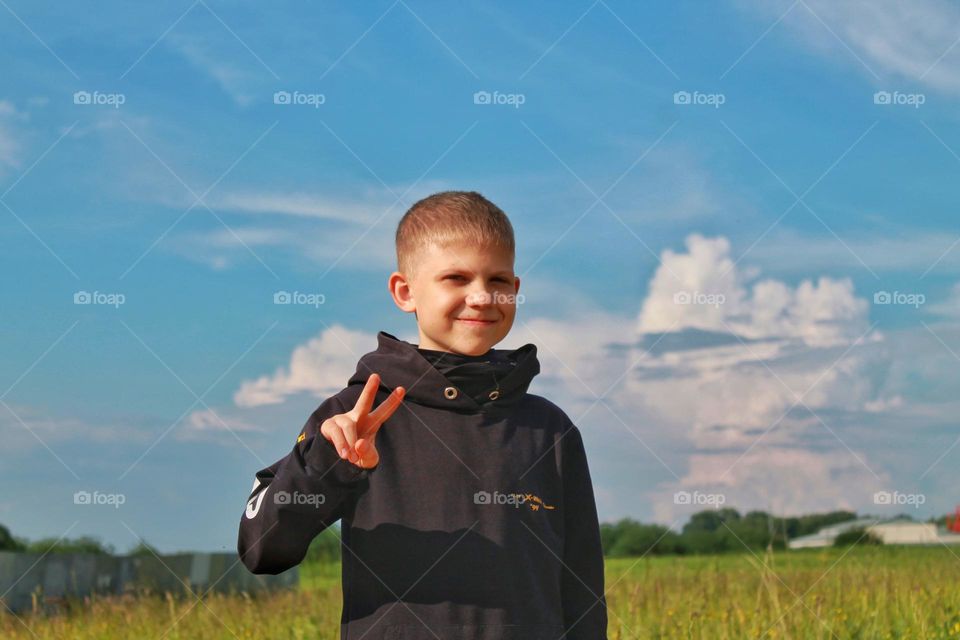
[560,424,607,640]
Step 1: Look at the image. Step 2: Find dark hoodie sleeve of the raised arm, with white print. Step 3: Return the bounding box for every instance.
[237,396,376,574]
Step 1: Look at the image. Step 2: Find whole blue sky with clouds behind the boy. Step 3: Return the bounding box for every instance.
[0,0,960,551]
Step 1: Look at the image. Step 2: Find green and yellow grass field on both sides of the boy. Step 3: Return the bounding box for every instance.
[0,546,960,640]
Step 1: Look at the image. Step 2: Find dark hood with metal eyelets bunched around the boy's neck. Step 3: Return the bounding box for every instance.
[349,331,540,413]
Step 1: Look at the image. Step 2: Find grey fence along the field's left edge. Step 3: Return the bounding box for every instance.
[0,551,299,613]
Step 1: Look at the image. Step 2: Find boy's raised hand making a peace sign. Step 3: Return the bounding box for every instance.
[320,373,406,469]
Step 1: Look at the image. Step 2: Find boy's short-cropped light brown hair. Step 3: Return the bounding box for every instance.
[396,191,516,277]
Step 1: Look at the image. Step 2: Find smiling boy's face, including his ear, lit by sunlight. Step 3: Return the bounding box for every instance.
[390,242,520,355]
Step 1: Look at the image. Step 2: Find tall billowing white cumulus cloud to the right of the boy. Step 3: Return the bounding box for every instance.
[624,234,888,520]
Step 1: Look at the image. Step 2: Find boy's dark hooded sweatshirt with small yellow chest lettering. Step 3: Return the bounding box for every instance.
[238,331,607,640]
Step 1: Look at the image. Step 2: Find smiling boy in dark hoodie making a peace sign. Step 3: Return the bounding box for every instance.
[238,191,607,640]
